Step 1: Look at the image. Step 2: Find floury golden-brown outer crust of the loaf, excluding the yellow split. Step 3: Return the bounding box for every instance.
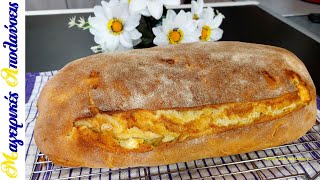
[35,42,316,167]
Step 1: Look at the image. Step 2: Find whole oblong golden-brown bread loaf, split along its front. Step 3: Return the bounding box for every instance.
[35,42,316,167]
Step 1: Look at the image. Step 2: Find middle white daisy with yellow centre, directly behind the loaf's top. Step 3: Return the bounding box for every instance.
[152,10,200,45]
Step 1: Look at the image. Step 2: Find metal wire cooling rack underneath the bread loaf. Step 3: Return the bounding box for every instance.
[30,117,320,180]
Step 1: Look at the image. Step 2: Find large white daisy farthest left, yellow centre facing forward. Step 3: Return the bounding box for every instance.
[88,0,142,51]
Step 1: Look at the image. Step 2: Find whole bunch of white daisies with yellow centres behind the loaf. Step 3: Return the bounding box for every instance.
[68,0,224,53]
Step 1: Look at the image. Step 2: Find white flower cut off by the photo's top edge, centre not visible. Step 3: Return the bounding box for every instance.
[128,0,180,19]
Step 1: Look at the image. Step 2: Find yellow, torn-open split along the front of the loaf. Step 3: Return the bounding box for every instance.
[74,71,310,152]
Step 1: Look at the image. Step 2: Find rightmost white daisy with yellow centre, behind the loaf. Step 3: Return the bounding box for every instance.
[197,7,224,41]
